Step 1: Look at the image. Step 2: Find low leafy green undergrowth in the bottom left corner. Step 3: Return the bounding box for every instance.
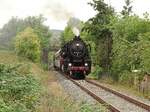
[0,64,40,112]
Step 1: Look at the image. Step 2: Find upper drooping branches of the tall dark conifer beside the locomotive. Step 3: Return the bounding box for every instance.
[84,0,113,39]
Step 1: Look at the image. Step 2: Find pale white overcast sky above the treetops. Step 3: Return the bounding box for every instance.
[0,0,150,29]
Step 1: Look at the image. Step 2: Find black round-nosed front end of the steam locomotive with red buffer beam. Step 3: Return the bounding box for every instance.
[68,36,91,76]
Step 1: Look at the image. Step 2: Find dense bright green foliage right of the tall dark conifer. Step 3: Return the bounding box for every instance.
[111,16,150,79]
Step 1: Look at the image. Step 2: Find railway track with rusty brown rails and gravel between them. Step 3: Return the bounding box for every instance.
[60,72,150,112]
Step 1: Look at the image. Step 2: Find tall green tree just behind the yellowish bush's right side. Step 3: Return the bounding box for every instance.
[24,15,51,64]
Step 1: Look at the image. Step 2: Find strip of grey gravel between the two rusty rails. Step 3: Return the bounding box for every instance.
[77,81,148,112]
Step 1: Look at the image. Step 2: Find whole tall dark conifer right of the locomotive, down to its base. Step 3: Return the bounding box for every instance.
[84,0,114,71]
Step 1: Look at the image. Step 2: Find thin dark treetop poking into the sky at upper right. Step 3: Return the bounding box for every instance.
[121,0,132,16]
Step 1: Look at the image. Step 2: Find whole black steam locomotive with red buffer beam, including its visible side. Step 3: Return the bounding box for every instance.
[53,36,91,78]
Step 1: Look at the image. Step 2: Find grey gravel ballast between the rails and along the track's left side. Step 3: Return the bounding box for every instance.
[53,72,148,112]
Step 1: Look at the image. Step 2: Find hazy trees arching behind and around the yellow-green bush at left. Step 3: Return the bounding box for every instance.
[0,15,51,63]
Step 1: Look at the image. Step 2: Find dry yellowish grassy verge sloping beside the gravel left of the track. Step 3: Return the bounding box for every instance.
[0,51,107,112]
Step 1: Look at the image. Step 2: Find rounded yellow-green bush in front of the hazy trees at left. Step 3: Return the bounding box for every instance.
[15,28,40,62]
